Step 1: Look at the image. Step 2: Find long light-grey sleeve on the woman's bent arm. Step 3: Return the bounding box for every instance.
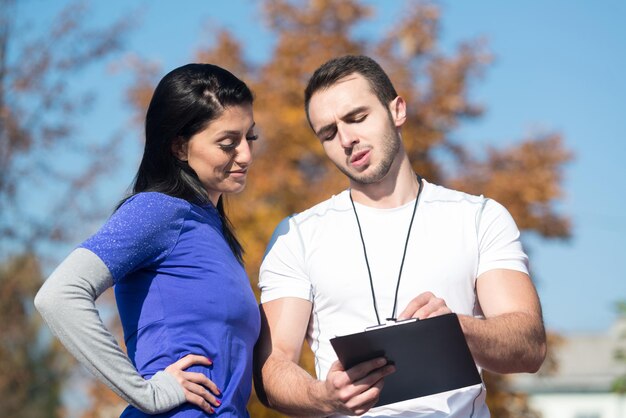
[35,248,185,414]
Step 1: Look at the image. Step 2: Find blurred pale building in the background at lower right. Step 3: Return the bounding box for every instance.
[511,317,626,418]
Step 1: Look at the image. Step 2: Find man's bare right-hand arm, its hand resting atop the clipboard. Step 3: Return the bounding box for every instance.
[398,269,546,373]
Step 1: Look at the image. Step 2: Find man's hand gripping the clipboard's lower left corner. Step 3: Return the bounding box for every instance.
[320,358,396,415]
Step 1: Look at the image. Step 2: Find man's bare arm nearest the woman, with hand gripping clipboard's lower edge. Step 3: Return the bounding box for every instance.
[254,298,395,417]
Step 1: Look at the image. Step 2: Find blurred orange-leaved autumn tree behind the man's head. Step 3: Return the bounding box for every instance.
[123,0,571,418]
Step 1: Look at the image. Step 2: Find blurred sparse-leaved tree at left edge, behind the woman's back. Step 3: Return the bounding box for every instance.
[0,0,128,418]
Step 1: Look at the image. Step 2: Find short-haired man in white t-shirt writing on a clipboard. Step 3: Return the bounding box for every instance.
[256,56,546,418]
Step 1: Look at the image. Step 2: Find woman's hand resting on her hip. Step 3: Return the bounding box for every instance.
[165,354,221,414]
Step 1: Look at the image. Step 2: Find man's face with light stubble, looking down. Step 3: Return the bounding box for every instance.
[309,74,404,184]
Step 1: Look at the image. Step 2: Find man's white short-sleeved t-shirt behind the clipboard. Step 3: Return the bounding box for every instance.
[259,180,528,418]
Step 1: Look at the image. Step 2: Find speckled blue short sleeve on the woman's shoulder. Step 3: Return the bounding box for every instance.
[79,192,190,283]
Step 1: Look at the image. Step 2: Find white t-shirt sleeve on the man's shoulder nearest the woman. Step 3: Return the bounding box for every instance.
[259,217,313,303]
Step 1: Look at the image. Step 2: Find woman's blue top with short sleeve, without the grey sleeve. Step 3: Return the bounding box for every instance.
[81,192,260,418]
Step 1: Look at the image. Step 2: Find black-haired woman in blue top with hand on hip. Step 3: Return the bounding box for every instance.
[35,64,260,418]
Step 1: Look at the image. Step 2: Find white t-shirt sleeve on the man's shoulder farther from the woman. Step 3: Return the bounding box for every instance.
[477,199,528,276]
